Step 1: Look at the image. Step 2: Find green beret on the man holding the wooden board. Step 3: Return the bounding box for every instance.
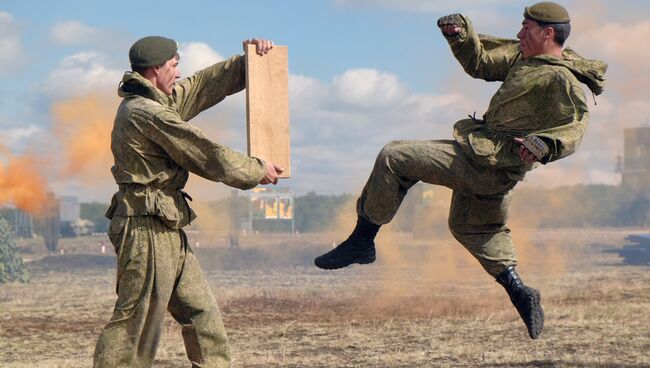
[129,36,178,68]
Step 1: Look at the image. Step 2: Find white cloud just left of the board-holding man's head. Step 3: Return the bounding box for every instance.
[37,51,123,100]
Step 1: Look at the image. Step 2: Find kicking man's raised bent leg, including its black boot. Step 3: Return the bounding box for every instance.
[314,140,514,269]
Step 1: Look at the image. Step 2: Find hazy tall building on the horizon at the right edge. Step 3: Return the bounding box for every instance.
[618,127,650,192]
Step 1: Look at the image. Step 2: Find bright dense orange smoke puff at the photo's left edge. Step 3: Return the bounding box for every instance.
[0,145,47,215]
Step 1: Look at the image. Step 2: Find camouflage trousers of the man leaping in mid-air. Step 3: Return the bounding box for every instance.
[357,140,517,277]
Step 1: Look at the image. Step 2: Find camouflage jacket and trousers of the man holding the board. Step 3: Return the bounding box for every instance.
[94,56,265,367]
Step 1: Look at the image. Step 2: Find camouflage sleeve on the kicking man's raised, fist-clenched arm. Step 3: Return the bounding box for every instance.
[445,16,520,81]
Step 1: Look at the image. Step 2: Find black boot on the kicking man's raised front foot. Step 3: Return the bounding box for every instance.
[314,217,380,270]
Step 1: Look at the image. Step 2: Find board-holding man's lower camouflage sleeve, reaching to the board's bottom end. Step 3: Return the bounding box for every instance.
[131,105,265,189]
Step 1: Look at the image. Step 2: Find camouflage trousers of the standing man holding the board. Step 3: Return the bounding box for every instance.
[94,216,230,368]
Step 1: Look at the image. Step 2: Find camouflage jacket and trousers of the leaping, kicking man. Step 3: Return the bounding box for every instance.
[357,17,606,277]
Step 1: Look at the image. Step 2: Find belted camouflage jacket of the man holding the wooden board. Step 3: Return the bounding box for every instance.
[106,56,264,229]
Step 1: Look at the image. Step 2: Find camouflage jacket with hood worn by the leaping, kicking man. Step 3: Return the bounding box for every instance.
[446,17,607,180]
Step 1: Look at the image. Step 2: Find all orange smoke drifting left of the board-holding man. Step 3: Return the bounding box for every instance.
[0,95,117,215]
